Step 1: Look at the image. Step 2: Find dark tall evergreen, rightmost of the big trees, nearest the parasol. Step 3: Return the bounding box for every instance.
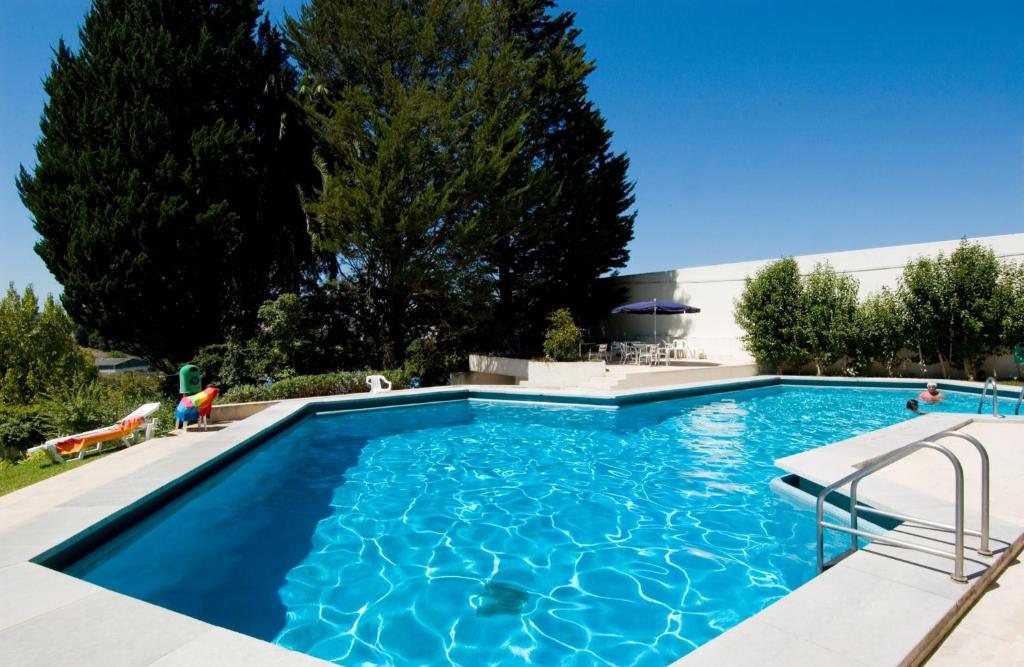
[486,0,636,352]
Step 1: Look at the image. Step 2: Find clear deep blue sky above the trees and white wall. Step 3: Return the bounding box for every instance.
[0,0,1024,292]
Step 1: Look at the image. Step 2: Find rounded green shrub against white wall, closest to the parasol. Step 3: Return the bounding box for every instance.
[735,257,810,369]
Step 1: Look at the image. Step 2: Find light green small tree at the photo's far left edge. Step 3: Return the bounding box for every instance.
[0,284,96,404]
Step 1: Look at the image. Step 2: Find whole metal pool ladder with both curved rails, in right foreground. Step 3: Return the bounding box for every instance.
[816,430,992,583]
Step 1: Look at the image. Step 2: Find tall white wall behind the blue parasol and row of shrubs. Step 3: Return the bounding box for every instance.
[594,234,1024,361]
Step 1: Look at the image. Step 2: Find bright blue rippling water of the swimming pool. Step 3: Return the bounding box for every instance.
[67,386,977,665]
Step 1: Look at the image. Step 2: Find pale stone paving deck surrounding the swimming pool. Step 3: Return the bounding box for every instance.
[0,382,1024,667]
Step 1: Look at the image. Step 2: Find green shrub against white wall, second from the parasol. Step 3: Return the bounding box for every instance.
[800,262,857,375]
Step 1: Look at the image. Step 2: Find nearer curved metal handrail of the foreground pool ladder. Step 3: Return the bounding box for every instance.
[816,440,970,583]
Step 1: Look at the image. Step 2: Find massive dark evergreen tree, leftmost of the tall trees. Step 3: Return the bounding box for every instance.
[17,0,311,362]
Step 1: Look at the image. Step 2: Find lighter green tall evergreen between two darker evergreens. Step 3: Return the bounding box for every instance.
[288,0,523,366]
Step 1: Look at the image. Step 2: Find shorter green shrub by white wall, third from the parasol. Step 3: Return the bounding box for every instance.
[850,287,907,377]
